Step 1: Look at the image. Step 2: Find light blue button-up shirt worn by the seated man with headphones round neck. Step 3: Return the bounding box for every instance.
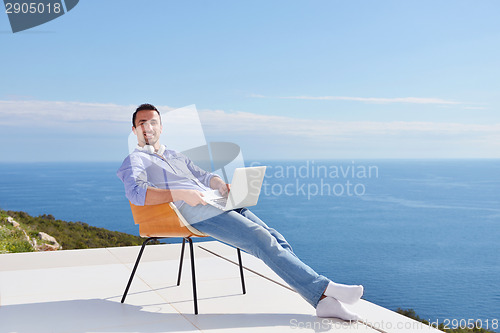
[116,146,218,208]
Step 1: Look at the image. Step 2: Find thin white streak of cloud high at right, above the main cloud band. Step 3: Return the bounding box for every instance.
[254,94,462,105]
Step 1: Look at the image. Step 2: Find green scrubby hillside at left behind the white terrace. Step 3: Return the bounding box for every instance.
[0,210,144,253]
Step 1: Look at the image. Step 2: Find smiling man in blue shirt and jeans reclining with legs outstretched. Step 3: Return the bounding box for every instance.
[117,104,363,320]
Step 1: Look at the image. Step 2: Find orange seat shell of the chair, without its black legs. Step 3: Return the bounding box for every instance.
[130,203,207,237]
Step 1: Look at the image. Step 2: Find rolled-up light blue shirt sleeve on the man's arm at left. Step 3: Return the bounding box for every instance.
[116,155,156,206]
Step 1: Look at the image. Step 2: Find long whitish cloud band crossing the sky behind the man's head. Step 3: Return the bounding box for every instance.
[0,100,500,138]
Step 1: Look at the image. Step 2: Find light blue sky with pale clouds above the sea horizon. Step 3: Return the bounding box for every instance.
[0,0,500,162]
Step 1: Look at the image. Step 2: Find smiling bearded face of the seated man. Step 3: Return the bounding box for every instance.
[132,110,163,149]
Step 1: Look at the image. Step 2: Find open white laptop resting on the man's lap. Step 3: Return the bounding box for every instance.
[203,166,266,211]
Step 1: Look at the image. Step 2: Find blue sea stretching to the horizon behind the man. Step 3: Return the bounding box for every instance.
[0,159,500,331]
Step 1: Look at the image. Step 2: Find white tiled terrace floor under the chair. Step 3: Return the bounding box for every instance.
[0,242,439,333]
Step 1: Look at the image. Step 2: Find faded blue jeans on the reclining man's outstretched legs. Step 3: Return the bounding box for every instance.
[179,204,330,307]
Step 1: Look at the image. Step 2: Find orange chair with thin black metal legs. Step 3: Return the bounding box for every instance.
[121,203,246,314]
